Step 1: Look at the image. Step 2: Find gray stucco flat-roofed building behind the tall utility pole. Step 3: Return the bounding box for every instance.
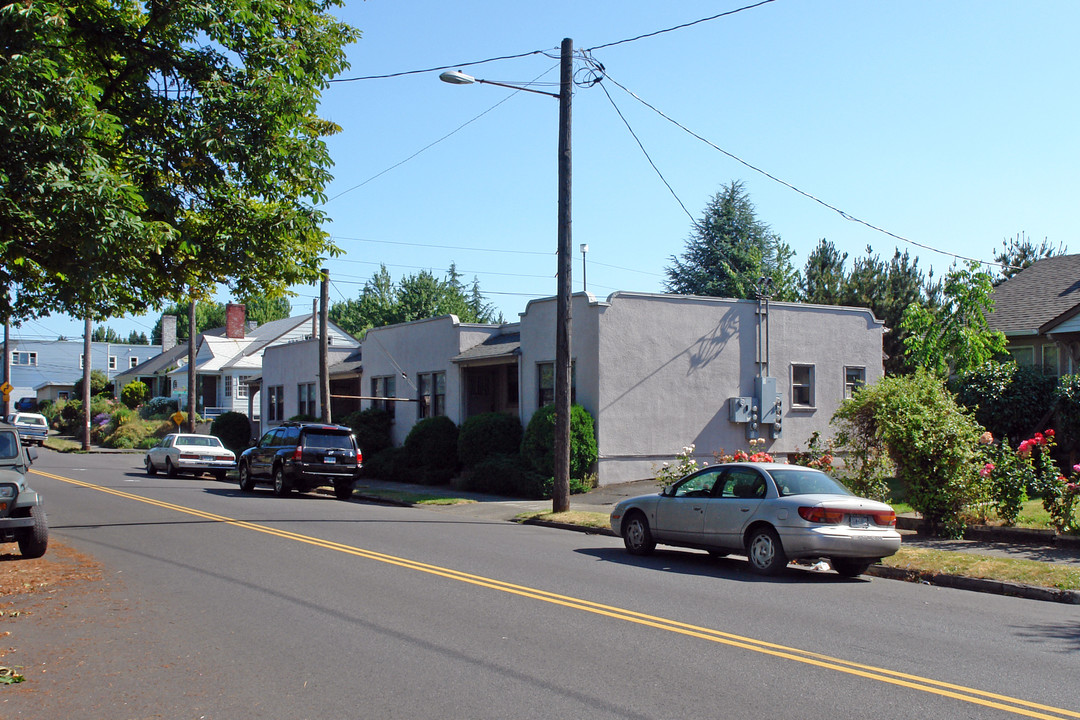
[358,293,883,485]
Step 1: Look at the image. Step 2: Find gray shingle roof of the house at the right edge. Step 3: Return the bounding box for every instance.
[989,255,1080,335]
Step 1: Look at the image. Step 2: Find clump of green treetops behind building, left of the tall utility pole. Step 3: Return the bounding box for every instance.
[329,264,502,337]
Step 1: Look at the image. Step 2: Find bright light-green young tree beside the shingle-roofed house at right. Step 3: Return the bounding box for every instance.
[901,261,1005,378]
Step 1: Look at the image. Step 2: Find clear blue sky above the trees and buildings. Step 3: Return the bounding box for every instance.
[16,0,1080,339]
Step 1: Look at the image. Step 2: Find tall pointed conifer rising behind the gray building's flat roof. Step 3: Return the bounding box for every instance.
[664,180,799,300]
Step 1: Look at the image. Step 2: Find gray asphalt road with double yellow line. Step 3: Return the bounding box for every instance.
[0,451,1080,720]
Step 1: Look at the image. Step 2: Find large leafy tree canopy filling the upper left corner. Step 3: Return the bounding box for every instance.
[0,0,357,320]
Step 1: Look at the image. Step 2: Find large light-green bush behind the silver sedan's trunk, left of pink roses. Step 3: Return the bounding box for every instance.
[834,368,983,536]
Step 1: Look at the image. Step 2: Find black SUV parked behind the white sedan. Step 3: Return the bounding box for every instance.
[237,422,363,500]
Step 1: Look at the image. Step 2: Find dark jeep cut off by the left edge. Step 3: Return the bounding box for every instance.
[0,423,49,558]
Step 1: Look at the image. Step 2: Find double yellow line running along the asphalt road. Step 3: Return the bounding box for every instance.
[31,470,1080,720]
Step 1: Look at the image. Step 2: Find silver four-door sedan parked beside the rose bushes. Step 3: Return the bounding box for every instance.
[611,463,900,578]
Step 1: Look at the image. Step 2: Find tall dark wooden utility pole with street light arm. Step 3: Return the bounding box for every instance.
[438,38,573,513]
